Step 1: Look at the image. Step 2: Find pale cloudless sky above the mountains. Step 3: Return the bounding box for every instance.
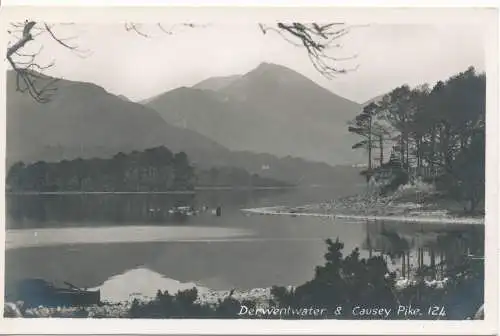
[11,23,485,103]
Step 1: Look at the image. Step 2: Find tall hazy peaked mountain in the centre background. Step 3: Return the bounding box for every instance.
[146,63,363,165]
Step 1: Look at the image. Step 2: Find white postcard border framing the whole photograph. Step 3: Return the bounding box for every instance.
[0,1,500,335]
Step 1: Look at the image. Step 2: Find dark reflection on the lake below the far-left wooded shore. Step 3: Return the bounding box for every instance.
[6,190,294,229]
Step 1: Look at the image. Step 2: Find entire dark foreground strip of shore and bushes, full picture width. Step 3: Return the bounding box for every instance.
[5,239,484,320]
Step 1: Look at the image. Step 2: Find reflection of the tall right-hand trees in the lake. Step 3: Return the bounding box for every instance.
[362,222,485,278]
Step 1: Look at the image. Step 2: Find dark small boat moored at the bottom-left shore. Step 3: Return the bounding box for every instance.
[16,279,101,307]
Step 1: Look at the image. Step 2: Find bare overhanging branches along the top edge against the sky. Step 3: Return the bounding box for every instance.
[6,20,360,103]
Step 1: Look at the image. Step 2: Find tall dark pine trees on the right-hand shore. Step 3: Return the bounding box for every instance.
[349,67,486,212]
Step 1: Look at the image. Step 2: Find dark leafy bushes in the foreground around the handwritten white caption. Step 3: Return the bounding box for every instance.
[126,239,484,319]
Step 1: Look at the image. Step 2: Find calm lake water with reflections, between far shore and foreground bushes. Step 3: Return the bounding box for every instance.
[5,188,484,299]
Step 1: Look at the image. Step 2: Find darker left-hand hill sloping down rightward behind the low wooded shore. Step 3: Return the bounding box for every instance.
[6,72,366,188]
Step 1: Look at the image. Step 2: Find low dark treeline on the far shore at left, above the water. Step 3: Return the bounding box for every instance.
[6,146,286,192]
